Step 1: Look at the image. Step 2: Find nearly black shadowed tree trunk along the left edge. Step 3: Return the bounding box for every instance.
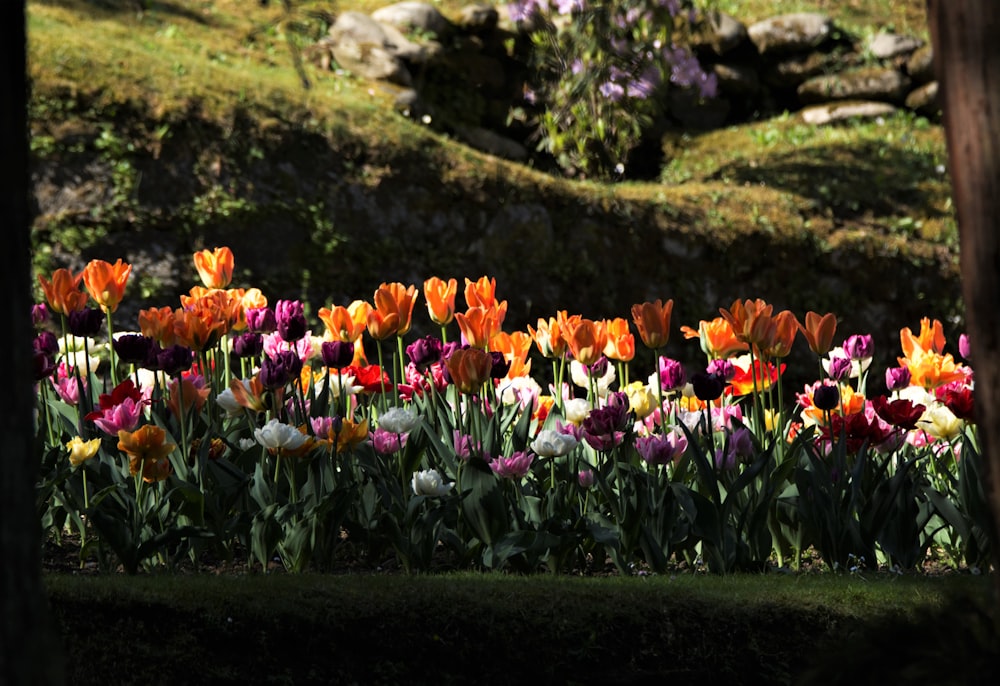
[0,0,63,685]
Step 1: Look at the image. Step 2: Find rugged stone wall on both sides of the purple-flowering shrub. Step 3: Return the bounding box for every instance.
[308,1,940,160]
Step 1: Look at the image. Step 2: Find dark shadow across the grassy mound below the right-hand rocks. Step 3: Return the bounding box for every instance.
[711,141,944,220]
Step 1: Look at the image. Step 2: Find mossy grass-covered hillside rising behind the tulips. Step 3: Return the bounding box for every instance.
[28,0,961,376]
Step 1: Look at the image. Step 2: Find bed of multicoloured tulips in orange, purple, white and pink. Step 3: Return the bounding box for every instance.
[34,248,992,574]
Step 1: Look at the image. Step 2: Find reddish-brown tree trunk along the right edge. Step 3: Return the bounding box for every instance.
[927,0,1000,608]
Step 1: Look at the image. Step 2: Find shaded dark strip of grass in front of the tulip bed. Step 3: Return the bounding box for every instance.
[45,574,989,685]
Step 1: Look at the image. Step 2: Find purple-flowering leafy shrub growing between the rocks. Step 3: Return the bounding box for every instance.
[507,0,716,179]
